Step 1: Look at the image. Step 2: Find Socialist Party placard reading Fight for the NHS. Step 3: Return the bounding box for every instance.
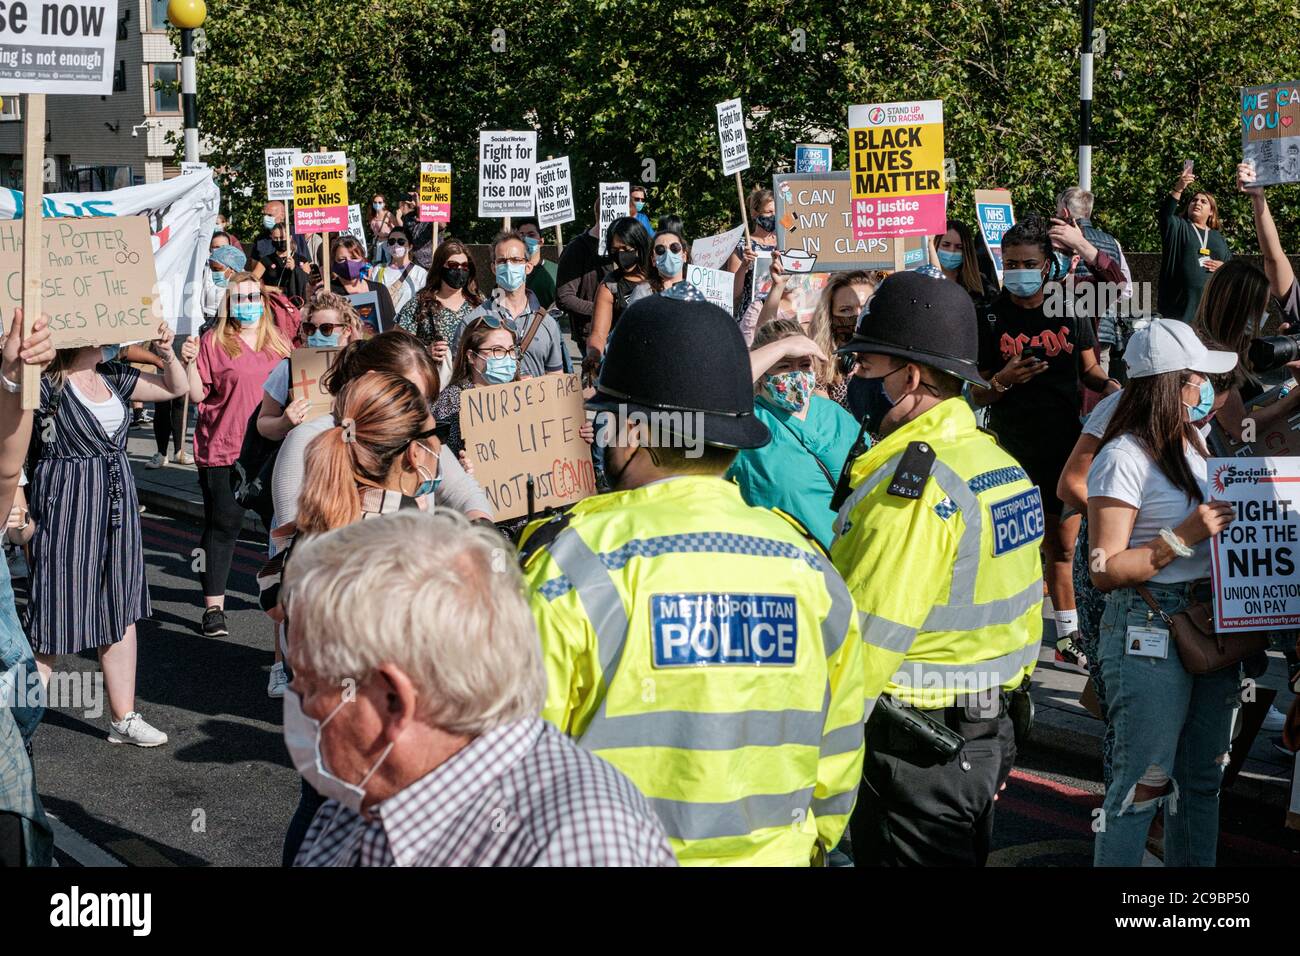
[1209,458,1300,633]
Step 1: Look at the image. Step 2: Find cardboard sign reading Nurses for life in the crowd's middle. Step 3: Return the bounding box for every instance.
[460,372,595,522]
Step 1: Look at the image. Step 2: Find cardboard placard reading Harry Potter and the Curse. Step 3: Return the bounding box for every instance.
[0,216,163,349]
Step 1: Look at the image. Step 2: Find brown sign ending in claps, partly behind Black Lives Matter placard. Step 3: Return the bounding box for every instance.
[774,170,894,272]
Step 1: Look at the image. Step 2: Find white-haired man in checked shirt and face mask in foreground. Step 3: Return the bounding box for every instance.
[283,509,676,866]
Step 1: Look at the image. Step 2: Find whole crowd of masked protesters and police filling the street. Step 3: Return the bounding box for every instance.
[0,108,1300,866]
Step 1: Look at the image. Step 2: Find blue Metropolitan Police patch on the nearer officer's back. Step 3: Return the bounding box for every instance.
[650,592,798,667]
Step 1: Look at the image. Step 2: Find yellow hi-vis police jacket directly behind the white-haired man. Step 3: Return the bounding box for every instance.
[520,476,863,866]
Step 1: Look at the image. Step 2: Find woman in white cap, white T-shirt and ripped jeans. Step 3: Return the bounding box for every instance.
[1088,319,1240,866]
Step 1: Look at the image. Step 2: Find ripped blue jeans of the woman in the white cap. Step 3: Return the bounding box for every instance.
[1092,583,1242,866]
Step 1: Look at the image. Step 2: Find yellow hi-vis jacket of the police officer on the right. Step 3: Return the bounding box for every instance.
[831,398,1044,714]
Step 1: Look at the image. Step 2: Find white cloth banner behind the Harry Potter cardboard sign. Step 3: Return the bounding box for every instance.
[0,169,221,336]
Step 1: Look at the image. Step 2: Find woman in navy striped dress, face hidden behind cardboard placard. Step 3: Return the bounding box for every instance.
[25,323,199,747]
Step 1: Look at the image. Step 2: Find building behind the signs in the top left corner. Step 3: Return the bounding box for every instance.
[0,0,182,193]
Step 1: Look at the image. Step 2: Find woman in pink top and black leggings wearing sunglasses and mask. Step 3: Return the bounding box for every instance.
[187,272,298,637]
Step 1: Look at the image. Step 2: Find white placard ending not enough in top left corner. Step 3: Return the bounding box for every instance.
[0,0,118,94]
